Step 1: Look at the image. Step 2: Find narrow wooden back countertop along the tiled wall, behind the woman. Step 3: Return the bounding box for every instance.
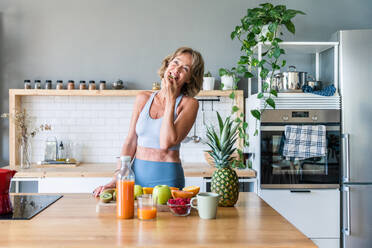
[4,163,256,178]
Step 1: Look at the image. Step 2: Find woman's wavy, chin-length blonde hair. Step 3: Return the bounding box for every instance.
[158,47,204,97]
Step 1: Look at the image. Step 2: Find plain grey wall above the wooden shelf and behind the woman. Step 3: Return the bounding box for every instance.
[0,0,372,161]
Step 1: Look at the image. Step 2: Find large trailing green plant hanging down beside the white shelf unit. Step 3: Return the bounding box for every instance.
[220,3,305,167]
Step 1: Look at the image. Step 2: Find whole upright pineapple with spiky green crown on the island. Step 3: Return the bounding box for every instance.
[207,112,239,207]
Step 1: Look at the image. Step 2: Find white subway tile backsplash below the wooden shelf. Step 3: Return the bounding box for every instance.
[22,96,232,163]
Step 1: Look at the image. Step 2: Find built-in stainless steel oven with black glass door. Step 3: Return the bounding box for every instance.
[260,110,341,189]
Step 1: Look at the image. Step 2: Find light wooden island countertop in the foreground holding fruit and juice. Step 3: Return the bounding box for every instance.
[0,193,316,248]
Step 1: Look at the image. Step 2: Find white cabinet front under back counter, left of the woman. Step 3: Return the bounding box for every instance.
[39,177,112,193]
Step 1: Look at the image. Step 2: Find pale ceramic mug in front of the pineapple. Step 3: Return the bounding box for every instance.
[190,192,220,219]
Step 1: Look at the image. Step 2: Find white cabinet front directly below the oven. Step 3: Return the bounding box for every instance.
[260,189,340,239]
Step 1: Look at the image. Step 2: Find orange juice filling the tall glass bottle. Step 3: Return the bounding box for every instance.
[116,180,134,219]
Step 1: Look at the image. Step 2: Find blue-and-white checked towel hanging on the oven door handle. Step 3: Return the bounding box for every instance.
[283,125,327,160]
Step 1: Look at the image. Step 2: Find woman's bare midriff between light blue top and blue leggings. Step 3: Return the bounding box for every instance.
[136,146,181,163]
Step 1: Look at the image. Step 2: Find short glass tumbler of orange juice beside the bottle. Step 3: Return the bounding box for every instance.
[137,194,157,220]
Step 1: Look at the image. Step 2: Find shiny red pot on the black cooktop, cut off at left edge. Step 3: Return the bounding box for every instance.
[0,169,17,215]
